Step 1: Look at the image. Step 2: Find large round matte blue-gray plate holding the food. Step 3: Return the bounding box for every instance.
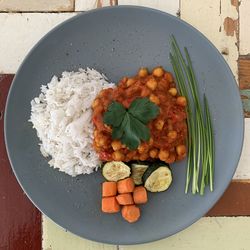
[5,6,244,244]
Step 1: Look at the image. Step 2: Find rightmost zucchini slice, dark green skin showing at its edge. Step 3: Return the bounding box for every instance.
[142,165,172,192]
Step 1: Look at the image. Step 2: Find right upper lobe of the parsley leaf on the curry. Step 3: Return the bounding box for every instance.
[129,98,160,124]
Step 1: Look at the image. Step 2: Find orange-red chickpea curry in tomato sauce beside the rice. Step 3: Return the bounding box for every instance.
[92,67,187,163]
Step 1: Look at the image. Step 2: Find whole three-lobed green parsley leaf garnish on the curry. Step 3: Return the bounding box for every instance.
[103,98,159,150]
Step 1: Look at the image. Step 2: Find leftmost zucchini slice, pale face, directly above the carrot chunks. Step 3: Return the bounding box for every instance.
[102,161,131,181]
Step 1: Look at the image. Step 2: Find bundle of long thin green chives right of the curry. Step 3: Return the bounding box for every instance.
[170,36,214,195]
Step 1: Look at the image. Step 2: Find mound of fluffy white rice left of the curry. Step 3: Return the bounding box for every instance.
[30,68,114,176]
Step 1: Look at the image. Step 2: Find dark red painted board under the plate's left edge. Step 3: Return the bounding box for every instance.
[0,75,42,250]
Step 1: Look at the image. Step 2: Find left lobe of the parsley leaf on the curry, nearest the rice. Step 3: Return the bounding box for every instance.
[103,101,126,127]
